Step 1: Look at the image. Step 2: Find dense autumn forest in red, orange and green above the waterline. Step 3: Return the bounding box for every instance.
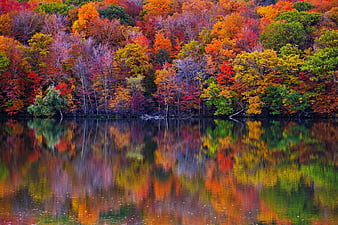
[0,0,338,117]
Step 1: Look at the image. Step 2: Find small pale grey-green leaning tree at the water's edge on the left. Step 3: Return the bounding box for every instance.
[27,87,67,118]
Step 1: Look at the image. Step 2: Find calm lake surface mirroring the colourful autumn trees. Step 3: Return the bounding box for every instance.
[0,120,338,225]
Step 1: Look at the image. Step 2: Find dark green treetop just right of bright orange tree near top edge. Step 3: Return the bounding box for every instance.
[99,4,132,25]
